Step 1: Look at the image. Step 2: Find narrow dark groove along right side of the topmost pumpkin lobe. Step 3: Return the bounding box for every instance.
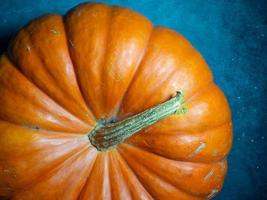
[115,25,155,117]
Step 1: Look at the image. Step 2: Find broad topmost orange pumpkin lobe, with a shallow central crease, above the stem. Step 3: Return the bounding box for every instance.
[65,4,154,118]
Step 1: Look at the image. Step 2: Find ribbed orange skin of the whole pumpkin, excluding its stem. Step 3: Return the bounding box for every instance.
[0,3,232,200]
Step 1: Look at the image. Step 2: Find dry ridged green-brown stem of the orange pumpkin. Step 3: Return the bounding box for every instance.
[88,92,186,151]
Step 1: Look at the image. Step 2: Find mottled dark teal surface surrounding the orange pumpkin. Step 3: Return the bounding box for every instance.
[0,0,267,200]
